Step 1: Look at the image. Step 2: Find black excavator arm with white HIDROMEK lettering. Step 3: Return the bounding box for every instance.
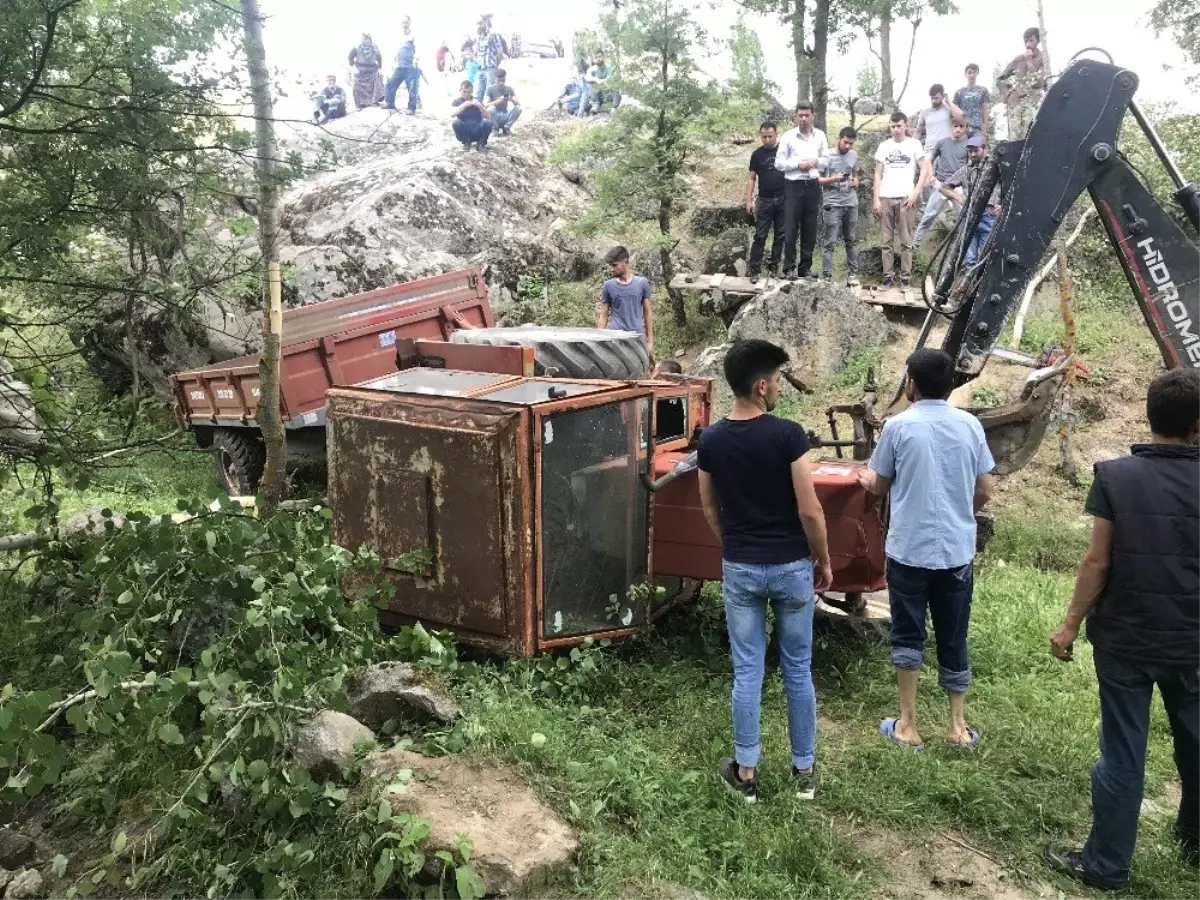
[937,60,1200,384]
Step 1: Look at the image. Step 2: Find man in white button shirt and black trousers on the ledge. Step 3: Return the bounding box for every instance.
[775,102,829,278]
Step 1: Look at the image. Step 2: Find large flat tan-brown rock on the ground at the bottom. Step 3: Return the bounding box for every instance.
[364,749,578,898]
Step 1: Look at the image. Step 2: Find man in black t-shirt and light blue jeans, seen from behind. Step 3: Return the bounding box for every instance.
[697,341,833,803]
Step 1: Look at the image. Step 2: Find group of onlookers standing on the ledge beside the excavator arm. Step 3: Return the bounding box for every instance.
[745,28,1045,289]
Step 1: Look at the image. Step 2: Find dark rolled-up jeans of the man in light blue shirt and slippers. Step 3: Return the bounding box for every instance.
[888,557,974,694]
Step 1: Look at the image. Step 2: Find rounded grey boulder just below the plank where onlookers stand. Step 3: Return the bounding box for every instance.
[730,281,890,384]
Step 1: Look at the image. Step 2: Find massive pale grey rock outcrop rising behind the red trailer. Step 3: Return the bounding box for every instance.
[72,92,592,394]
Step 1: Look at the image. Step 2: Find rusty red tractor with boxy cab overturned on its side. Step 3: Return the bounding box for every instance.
[326,342,883,656]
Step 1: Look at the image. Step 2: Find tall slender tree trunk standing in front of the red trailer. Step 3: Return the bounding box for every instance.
[241,0,288,512]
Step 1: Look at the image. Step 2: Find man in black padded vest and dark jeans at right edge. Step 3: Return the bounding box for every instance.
[1046,368,1200,889]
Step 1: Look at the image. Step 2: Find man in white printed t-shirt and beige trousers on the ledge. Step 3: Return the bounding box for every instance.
[874,113,930,289]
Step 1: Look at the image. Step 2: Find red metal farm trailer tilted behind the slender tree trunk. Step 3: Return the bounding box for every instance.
[170,269,496,494]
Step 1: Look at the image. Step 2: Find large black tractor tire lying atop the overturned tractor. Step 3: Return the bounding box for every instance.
[450,325,650,380]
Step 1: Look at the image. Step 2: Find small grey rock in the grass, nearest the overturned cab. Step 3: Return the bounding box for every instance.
[346,662,460,731]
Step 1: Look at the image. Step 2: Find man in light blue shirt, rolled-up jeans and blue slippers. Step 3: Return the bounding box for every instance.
[858,349,996,750]
